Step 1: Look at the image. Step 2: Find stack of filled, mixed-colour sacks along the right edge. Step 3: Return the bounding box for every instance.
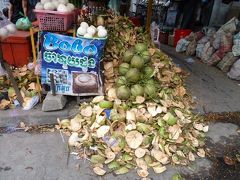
[176,18,240,79]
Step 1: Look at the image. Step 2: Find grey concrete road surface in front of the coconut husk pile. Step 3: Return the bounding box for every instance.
[0,123,240,180]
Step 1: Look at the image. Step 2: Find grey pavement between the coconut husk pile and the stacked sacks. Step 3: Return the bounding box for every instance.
[160,44,240,113]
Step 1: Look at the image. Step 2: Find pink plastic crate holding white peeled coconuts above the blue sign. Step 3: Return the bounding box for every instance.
[34,9,75,31]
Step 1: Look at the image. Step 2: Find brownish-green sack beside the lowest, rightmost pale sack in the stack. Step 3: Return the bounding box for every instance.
[217,52,237,72]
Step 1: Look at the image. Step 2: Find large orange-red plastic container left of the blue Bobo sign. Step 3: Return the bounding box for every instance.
[1,31,32,67]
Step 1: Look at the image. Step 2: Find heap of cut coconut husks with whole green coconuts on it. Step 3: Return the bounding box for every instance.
[57,15,208,178]
